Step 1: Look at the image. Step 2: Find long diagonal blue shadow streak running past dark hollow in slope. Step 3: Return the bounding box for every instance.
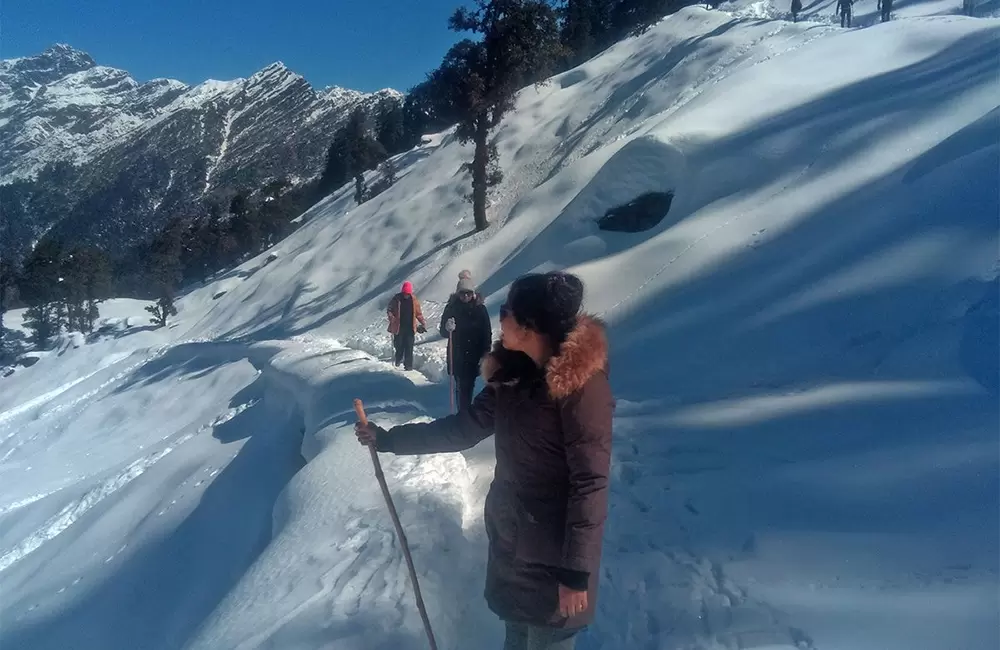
[482,31,1000,294]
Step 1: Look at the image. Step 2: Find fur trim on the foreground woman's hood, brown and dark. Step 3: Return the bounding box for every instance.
[481,314,608,399]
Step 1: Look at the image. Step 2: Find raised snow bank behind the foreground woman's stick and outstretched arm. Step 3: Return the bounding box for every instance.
[190,340,499,650]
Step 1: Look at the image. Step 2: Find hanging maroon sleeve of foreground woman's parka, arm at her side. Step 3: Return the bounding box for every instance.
[560,373,614,573]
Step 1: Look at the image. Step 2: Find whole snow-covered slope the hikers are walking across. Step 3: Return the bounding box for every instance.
[0,7,1000,650]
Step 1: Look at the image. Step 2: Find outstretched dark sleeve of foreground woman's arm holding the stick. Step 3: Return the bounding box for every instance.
[378,386,496,456]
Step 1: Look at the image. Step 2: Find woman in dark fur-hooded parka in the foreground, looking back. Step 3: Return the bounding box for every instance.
[355,272,614,650]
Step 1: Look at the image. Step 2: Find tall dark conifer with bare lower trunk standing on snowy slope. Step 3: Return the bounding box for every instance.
[446,0,561,230]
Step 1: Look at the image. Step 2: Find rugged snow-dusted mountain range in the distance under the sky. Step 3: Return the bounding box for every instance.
[0,45,400,250]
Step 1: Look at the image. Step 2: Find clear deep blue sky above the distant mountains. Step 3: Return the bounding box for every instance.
[0,0,462,91]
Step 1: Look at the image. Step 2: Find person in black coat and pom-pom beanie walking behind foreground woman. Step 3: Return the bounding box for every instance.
[439,271,493,411]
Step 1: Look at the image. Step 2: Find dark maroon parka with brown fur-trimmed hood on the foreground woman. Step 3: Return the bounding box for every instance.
[378,316,614,628]
